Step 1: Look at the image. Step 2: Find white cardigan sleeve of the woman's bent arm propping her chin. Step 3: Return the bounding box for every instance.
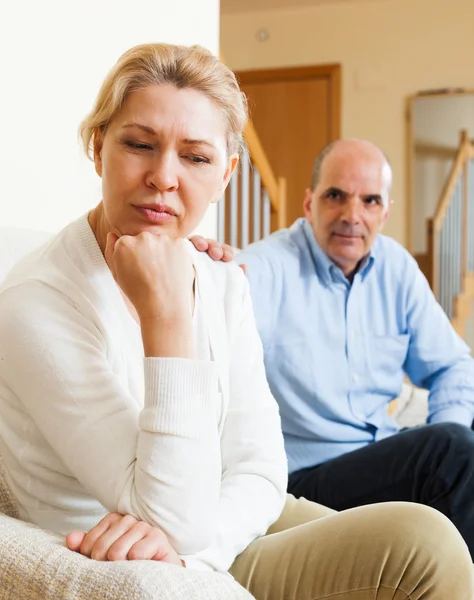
[0,281,221,554]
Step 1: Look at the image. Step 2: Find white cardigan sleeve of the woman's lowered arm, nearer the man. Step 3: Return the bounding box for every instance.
[184,267,288,571]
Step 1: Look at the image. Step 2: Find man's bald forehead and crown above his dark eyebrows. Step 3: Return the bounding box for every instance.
[318,152,392,200]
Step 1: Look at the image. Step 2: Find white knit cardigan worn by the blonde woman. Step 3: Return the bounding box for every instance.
[0,216,287,570]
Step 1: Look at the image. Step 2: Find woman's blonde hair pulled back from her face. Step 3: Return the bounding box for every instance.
[79,44,247,159]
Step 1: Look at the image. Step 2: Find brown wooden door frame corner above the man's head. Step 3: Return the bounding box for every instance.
[234,63,342,141]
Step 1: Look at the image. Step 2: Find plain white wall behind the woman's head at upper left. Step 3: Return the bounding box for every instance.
[0,0,219,236]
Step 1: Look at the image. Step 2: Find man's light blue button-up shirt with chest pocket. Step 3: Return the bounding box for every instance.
[237,219,474,472]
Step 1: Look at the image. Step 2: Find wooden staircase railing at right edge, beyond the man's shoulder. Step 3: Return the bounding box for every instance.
[420,131,474,337]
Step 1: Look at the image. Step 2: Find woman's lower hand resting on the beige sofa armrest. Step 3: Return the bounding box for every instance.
[66,513,184,567]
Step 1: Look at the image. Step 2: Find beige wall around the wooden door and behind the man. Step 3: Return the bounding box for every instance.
[221,0,474,243]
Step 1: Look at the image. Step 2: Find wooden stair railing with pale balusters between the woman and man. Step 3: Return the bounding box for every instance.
[217,120,287,248]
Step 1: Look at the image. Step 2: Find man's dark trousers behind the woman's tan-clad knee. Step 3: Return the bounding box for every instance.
[288,423,474,558]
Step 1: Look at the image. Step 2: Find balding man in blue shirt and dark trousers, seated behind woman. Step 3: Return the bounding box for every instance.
[193,140,474,556]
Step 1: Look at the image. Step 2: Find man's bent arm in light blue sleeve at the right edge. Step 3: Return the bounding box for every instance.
[404,261,474,427]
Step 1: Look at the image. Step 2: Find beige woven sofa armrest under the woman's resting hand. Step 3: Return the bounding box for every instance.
[0,514,252,600]
